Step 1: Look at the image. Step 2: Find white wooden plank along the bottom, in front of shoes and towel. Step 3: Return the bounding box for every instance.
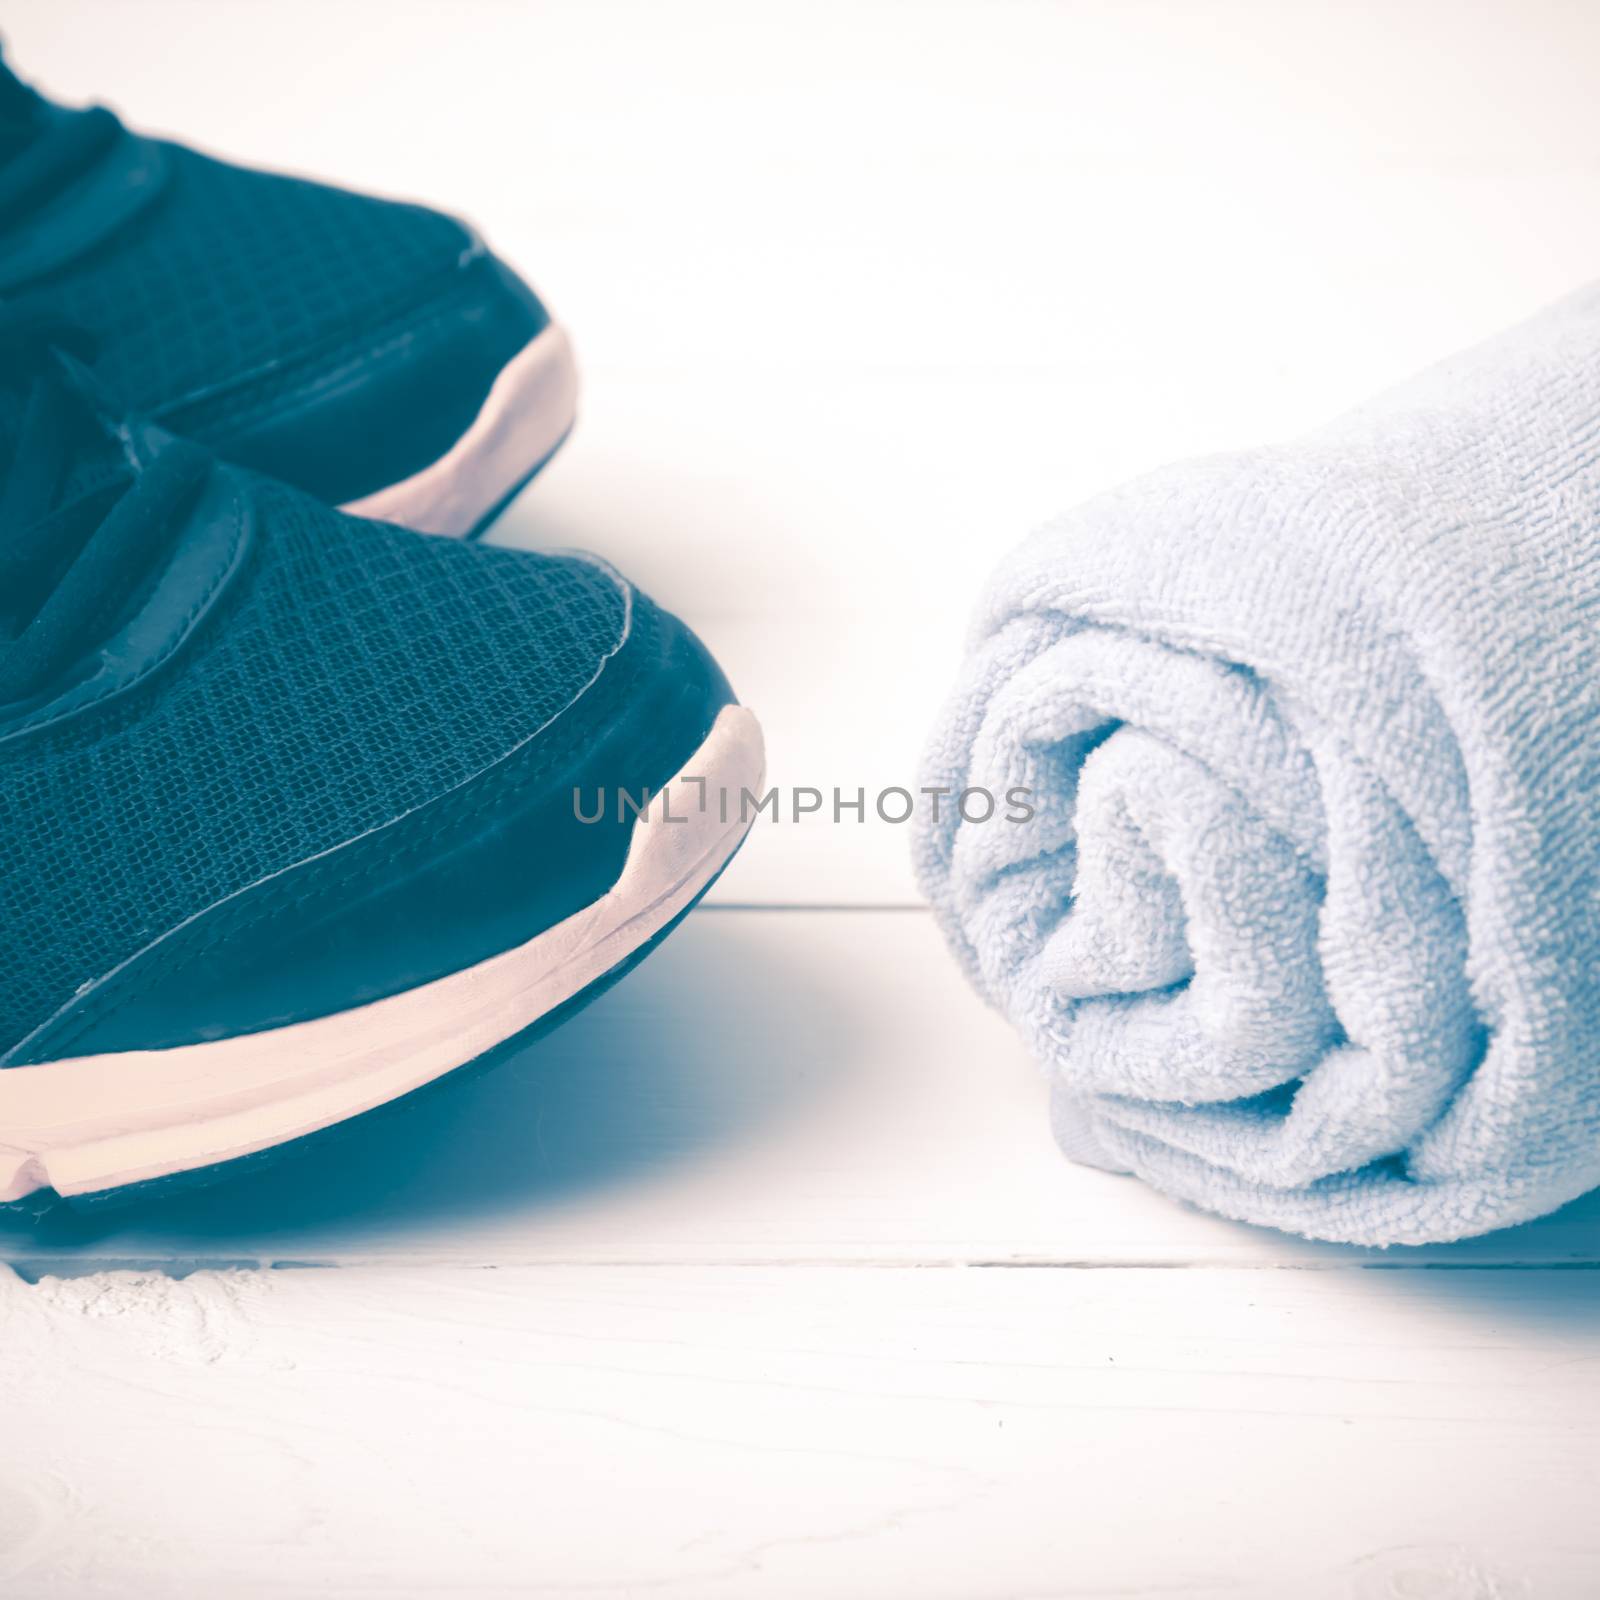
[0,1267,1600,1600]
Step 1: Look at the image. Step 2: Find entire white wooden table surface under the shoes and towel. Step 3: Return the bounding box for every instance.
[9,0,1600,1600]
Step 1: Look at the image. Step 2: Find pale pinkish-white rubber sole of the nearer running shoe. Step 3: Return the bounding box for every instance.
[0,706,763,1200]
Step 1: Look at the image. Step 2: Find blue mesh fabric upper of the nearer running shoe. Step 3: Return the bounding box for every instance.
[0,480,626,1051]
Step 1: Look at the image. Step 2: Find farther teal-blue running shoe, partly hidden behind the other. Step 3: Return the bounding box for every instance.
[0,51,578,534]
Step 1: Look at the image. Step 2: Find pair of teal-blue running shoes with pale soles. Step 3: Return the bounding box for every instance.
[0,50,762,1203]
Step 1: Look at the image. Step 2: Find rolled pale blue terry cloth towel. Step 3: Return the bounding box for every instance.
[917,286,1600,1245]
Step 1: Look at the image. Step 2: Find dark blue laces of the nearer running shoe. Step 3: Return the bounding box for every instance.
[0,306,210,706]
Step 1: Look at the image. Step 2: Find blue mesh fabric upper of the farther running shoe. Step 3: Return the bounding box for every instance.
[29,146,469,413]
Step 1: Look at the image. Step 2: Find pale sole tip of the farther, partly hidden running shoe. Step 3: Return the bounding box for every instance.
[341,322,578,539]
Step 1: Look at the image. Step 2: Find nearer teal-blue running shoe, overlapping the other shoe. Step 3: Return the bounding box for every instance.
[0,307,762,1200]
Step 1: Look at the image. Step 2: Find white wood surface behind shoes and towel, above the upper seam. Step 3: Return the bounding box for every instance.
[6,0,1600,904]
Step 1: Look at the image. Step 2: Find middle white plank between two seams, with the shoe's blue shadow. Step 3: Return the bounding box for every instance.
[0,910,1600,1270]
